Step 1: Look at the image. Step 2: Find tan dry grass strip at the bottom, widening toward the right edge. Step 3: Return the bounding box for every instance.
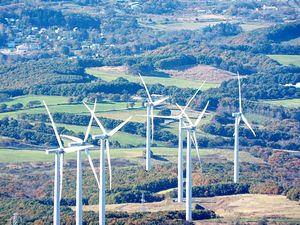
[82,194,300,221]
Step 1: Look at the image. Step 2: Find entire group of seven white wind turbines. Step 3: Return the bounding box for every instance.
[43,74,255,225]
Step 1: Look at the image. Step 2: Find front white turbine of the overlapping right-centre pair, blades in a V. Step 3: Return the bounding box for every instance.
[177,101,209,222]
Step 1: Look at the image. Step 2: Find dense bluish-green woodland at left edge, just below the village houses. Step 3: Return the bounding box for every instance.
[0,59,94,90]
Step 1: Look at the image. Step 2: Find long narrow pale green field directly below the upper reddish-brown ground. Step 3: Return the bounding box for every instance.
[86,68,219,90]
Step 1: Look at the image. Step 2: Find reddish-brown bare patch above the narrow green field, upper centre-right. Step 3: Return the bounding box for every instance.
[162,65,235,83]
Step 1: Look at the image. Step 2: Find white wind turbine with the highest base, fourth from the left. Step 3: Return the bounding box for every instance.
[139,74,169,171]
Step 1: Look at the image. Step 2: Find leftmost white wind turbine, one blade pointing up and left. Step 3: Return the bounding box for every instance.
[43,101,91,225]
